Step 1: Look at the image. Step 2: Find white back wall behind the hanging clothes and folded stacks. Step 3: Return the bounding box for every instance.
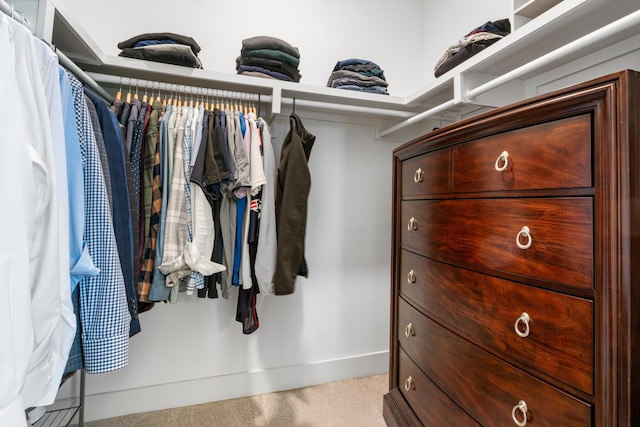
[51,0,423,420]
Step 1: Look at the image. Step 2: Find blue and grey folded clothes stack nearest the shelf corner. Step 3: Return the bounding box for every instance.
[327,58,389,95]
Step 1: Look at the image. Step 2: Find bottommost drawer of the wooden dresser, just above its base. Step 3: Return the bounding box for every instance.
[399,349,480,427]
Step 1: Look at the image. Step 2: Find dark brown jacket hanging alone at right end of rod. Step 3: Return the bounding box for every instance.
[273,113,316,295]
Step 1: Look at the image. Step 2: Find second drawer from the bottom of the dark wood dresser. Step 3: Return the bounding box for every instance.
[399,298,592,427]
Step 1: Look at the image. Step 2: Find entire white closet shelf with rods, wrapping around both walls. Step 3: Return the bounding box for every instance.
[52,0,640,138]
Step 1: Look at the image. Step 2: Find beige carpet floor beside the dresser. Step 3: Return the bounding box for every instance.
[86,374,389,427]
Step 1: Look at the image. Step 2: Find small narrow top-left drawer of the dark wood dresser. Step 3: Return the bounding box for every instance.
[401,149,451,197]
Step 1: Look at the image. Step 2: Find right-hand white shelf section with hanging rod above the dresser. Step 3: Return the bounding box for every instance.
[390,0,640,137]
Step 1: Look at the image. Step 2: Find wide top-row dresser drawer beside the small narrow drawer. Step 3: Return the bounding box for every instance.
[453,114,592,193]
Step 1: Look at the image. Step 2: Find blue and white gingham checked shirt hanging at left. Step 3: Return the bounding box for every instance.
[68,73,131,373]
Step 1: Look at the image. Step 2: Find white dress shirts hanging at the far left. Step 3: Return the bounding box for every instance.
[0,14,73,426]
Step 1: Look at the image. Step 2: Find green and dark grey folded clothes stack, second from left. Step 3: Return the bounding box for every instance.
[236,36,302,82]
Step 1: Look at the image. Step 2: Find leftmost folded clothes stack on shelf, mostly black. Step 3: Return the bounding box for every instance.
[118,33,202,68]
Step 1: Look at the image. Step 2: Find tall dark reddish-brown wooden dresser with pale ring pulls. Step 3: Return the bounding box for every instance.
[384,71,640,427]
